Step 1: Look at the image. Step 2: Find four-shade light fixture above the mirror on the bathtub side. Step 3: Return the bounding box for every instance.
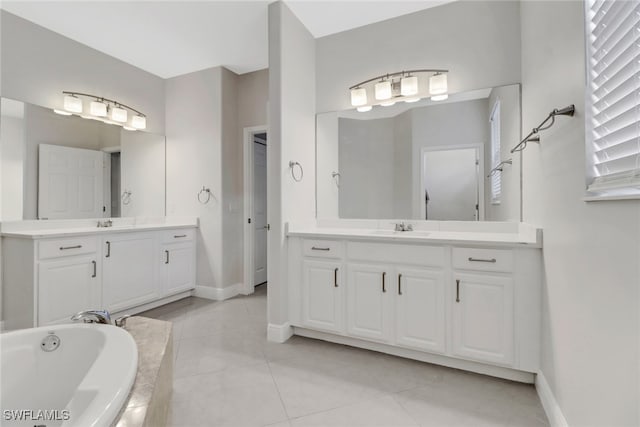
[53,91,147,131]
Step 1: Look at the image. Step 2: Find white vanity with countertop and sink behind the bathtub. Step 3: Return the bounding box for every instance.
[2,218,197,330]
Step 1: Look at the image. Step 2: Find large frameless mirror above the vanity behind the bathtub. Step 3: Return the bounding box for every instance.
[0,98,166,221]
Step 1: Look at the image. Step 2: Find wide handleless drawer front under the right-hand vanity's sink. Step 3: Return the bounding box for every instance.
[347,242,444,268]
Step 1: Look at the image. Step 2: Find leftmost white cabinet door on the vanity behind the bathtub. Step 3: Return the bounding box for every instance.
[38,256,101,326]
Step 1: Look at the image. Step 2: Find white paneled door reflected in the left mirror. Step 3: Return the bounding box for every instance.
[38,144,104,219]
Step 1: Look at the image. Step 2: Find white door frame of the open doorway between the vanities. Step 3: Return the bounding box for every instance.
[241,125,269,295]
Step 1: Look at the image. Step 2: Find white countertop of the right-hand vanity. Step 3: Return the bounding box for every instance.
[287,221,542,248]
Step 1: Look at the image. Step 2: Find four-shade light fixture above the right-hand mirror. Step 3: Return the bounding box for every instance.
[349,69,449,112]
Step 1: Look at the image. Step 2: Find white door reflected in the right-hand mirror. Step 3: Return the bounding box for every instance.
[420,148,479,221]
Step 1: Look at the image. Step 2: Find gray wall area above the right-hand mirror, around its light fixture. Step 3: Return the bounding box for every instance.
[316,0,520,112]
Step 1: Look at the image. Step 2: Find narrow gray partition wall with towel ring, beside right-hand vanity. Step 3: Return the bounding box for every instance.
[267,2,316,325]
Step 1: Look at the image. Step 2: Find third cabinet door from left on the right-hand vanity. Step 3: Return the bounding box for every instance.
[395,269,445,353]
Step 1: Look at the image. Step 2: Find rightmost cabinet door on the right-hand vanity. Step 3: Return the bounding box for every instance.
[452,274,514,365]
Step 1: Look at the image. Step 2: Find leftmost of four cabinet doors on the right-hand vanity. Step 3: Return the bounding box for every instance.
[302,260,343,332]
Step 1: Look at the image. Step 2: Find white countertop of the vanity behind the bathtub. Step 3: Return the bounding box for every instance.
[0,218,198,239]
